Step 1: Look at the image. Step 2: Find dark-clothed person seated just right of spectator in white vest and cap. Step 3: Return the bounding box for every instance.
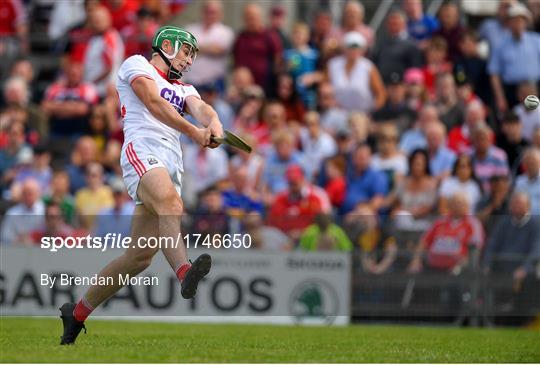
[373,72,416,131]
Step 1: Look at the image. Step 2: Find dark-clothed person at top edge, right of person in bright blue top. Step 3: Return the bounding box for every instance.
[434,1,464,62]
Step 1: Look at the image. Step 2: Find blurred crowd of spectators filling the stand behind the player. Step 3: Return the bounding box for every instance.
[0,0,540,279]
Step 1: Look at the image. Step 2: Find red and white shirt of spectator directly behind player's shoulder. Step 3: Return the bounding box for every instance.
[84,28,124,96]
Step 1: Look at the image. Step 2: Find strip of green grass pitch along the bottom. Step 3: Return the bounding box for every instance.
[0,317,540,363]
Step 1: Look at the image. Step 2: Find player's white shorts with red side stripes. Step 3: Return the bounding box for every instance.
[120,138,183,205]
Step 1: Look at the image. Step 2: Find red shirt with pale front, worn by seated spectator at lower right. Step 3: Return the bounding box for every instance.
[423,216,484,270]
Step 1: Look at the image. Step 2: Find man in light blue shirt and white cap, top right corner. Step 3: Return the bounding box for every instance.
[488,2,540,112]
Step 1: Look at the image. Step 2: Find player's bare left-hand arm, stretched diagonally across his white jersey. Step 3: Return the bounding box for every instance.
[131,77,212,146]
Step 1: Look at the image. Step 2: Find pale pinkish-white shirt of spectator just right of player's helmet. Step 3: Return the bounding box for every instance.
[185,23,234,85]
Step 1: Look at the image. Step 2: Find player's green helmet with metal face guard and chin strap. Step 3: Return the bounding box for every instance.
[152,26,199,80]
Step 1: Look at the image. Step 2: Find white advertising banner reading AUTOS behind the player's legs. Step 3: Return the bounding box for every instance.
[0,247,351,324]
